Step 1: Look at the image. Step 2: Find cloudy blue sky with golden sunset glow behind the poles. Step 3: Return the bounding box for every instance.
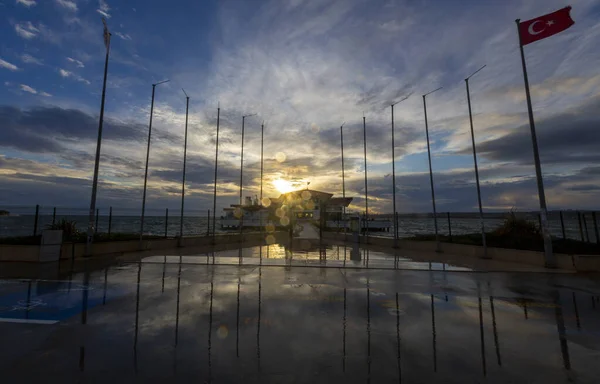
[0,0,600,214]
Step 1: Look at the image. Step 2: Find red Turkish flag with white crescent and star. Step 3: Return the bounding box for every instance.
[519,7,575,45]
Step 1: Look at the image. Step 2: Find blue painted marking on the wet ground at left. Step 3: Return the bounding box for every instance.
[0,281,126,321]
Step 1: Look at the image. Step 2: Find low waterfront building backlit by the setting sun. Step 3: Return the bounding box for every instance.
[221,189,352,228]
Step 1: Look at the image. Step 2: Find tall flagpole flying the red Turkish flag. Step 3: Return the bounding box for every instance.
[515,19,556,268]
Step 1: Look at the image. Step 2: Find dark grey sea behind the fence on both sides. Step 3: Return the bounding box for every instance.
[0,206,600,242]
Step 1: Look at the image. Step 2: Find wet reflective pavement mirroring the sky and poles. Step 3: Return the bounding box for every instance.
[0,245,600,383]
